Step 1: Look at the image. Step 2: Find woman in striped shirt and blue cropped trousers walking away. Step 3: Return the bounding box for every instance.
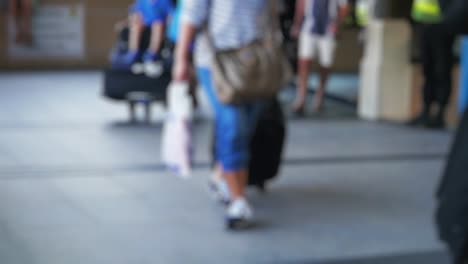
[173,0,280,229]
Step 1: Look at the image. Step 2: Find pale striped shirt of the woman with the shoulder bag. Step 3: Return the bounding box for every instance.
[182,0,268,50]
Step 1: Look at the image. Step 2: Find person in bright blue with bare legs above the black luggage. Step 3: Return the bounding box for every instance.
[126,0,174,76]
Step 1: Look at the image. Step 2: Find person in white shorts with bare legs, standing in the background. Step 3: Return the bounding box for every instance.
[291,0,348,115]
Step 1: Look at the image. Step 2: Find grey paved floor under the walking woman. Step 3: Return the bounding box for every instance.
[0,72,451,264]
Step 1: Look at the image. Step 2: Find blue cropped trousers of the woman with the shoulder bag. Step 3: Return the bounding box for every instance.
[197,68,264,173]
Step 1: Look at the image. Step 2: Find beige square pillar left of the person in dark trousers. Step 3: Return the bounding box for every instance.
[358,18,412,122]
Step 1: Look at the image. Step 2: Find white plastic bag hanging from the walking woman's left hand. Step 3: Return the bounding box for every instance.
[161,82,193,178]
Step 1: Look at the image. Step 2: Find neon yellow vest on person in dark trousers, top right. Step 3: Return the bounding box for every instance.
[412,0,442,24]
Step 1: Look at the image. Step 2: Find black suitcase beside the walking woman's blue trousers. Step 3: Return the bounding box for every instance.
[212,99,286,191]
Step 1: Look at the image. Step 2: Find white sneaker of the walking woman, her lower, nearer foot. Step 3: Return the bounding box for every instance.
[226,198,253,230]
